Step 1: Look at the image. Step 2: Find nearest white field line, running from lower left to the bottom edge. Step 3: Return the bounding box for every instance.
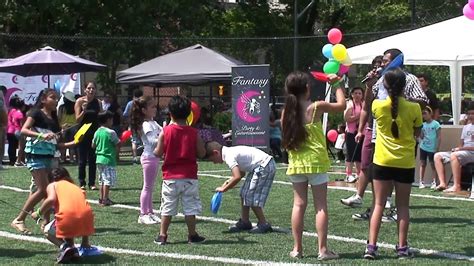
[0,231,309,265]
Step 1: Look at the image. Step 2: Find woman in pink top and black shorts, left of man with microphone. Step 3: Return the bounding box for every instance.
[344,87,364,183]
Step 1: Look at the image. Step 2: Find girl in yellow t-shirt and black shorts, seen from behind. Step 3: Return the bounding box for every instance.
[364,68,423,259]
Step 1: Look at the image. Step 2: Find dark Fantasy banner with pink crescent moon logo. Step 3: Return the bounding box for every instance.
[232,65,270,151]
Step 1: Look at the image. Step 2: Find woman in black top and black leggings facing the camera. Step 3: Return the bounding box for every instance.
[74,81,102,190]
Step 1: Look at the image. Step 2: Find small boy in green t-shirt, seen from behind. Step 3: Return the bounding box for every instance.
[92,111,120,206]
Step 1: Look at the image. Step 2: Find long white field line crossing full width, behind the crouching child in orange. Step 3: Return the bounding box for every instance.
[0,186,474,261]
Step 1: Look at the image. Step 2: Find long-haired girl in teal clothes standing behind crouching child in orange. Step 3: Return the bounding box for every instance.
[11,89,64,234]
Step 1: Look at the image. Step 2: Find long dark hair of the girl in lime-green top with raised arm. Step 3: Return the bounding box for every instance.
[281,71,309,150]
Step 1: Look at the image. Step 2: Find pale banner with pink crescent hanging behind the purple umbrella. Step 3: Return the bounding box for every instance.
[0,73,81,105]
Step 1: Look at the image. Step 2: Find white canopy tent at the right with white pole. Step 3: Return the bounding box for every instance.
[348,16,474,124]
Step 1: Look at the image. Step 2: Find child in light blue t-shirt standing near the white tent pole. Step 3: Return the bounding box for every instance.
[419,106,441,189]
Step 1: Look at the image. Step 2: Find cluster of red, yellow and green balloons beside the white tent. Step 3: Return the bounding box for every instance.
[322,28,352,76]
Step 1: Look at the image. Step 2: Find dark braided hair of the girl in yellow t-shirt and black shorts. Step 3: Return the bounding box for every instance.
[384,68,406,139]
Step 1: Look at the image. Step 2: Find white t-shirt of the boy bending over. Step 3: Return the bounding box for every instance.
[222,146,273,172]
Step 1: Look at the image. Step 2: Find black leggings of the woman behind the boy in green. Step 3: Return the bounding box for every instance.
[79,135,96,187]
